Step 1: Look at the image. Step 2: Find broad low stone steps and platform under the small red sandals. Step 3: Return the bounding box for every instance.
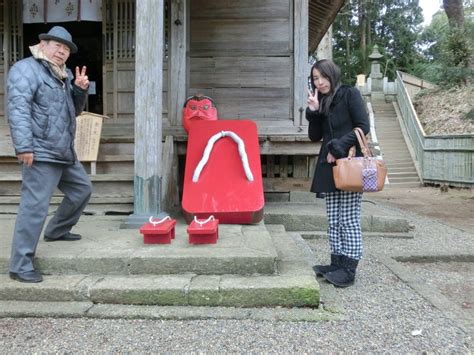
[0,197,413,321]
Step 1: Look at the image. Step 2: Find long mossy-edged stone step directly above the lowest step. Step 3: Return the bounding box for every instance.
[0,272,319,307]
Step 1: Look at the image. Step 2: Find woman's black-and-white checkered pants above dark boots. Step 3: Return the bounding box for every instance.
[326,191,363,260]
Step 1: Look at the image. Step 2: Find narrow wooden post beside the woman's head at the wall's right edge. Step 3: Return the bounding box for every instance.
[293,0,309,126]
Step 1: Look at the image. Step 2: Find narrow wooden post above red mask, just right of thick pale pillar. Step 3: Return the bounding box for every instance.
[168,0,187,126]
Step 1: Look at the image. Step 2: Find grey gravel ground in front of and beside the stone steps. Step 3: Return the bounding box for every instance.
[0,203,474,354]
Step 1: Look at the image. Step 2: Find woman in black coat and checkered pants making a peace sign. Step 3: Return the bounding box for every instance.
[306,59,370,287]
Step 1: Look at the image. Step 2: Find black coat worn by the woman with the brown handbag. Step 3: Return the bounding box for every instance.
[306,85,370,193]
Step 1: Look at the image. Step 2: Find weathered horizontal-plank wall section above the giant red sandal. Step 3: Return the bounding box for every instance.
[188,0,293,126]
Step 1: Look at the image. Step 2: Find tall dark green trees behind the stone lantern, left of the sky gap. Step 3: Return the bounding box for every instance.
[333,0,423,82]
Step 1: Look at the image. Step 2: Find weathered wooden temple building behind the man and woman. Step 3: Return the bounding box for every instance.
[0,0,344,225]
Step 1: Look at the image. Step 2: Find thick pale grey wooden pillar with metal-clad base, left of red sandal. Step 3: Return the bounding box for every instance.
[122,0,165,228]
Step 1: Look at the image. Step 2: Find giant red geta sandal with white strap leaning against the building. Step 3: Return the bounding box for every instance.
[182,120,264,224]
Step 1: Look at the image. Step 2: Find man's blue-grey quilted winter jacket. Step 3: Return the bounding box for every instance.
[8,57,87,164]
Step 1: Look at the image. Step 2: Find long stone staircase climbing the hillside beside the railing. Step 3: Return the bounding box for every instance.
[371,98,421,188]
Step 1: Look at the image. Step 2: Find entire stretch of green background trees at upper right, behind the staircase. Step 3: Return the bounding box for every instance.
[333,0,474,87]
